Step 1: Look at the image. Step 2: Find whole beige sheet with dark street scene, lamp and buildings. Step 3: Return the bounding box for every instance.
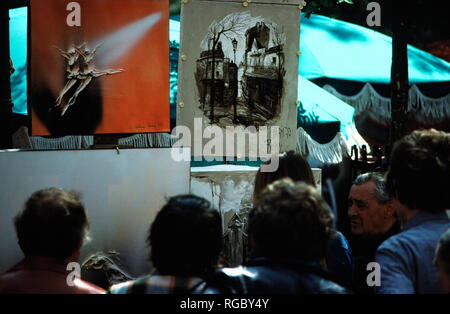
[176,0,300,158]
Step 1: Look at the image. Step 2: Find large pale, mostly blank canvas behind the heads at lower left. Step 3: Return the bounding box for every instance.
[0,148,190,276]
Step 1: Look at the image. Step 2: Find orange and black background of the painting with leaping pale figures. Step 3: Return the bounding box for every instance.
[30,0,170,136]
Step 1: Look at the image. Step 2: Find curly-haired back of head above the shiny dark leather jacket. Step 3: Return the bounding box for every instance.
[248,179,333,262]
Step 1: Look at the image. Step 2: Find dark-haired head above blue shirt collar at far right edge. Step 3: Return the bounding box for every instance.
[386,129,450,212]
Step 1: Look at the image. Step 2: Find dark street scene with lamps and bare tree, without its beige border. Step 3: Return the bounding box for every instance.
[194,12,286,127]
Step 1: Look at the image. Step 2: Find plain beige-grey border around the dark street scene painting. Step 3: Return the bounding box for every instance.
[177,1,300,157]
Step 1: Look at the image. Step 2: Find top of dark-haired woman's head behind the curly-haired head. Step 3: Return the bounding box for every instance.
[253,151,316,199]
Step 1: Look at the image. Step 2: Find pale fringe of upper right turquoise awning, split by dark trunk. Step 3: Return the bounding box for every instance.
[323,83,450,124]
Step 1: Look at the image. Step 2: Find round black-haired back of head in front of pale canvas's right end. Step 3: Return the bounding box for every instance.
[147,195,222,277]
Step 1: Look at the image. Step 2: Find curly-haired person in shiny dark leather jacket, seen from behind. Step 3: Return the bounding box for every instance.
[205,179,348,294]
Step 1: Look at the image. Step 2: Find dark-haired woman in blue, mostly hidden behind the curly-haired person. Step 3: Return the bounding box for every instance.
[253,151,354,287]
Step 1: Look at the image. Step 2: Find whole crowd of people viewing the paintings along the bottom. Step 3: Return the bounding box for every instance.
[0,130,450,295]
